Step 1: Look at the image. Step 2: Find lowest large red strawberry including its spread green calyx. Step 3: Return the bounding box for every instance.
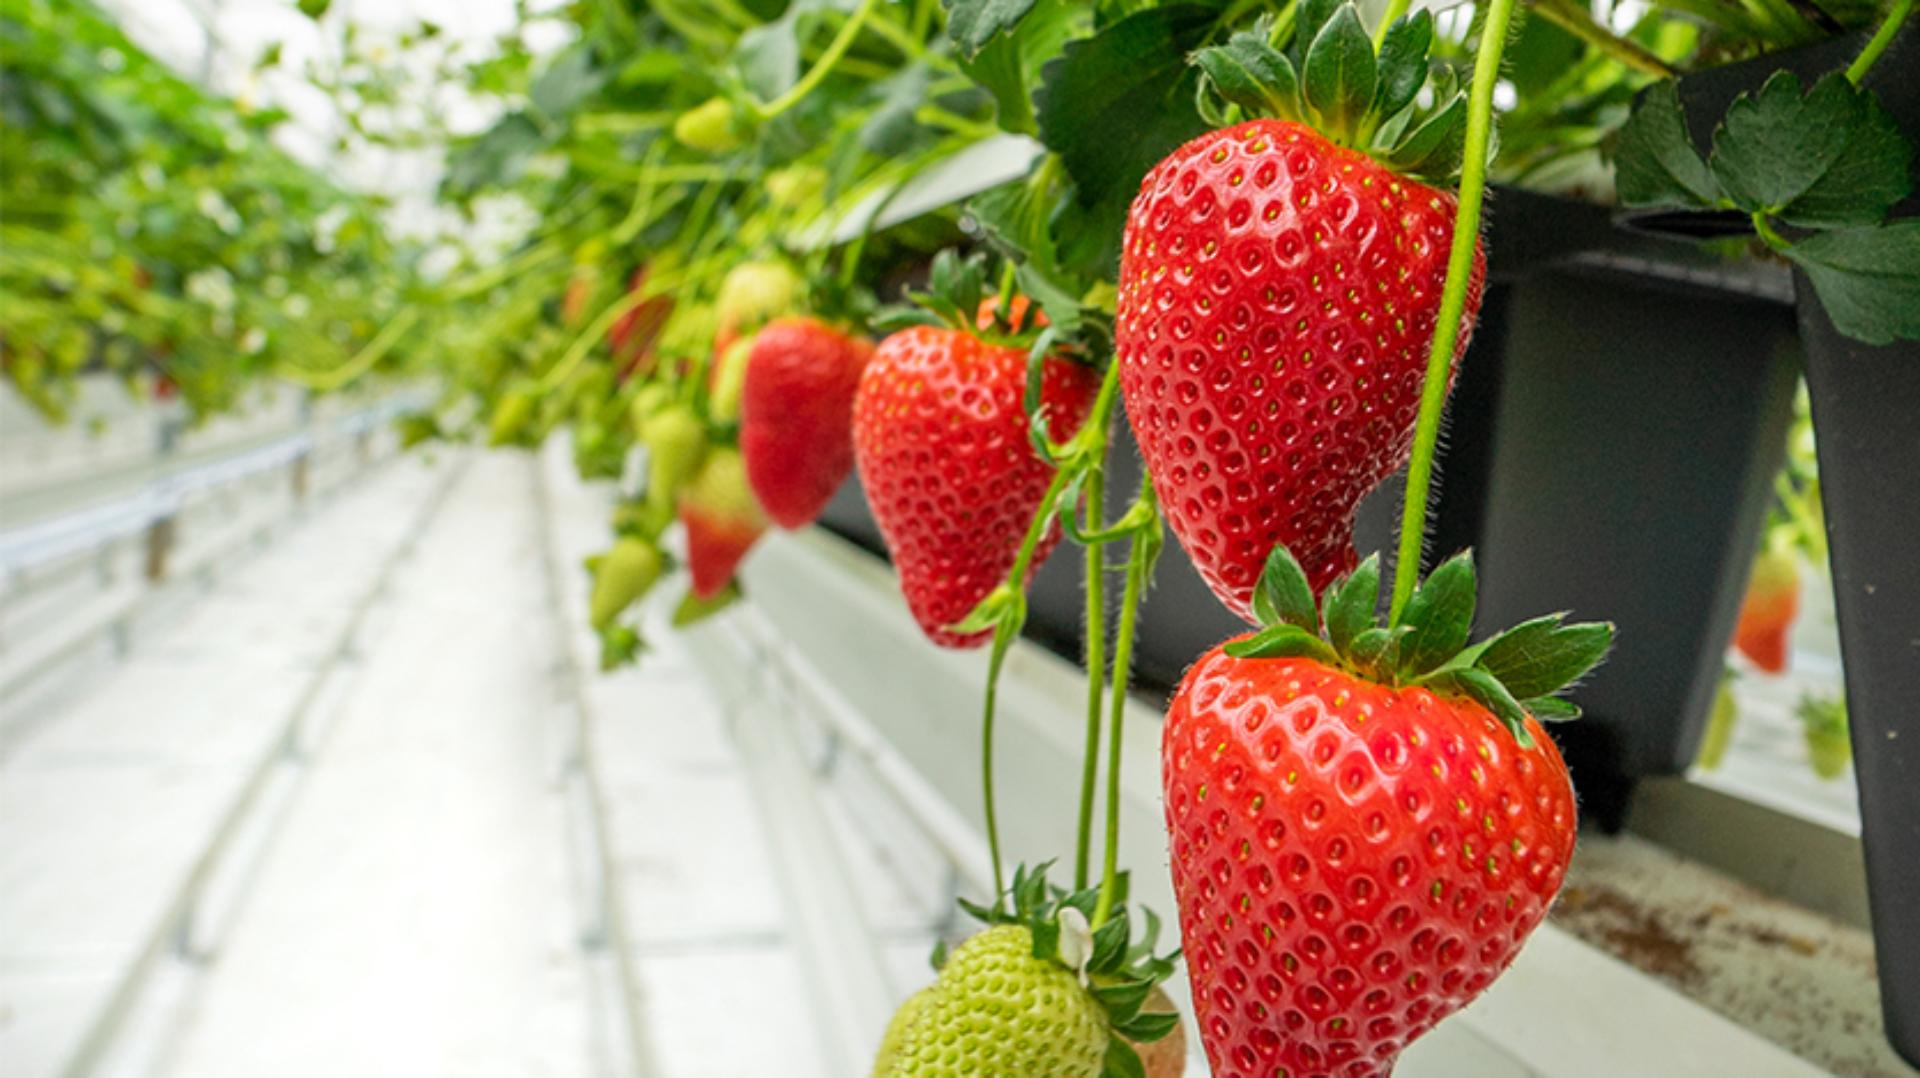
[1162,548,1613,1078]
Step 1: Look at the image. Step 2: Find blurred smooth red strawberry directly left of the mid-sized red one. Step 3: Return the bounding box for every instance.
[739,319,874,528]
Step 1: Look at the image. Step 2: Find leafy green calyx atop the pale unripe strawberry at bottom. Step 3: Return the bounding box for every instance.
[933,861,1179,1078]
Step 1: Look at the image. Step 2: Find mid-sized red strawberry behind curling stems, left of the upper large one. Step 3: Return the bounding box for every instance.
[852,317,1098,648]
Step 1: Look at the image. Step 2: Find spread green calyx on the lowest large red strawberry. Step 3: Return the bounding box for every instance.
[1225,544,1613,747]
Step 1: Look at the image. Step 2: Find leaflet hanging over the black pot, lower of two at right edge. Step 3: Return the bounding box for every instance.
[1786,219,1920,344]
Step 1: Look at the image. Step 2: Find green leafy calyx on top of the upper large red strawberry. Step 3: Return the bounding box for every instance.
[1192,0,1467,184]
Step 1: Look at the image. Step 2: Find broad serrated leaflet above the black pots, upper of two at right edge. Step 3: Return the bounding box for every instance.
[1707,71,1912,227]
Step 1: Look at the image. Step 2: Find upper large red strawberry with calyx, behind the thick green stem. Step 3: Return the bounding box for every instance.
[1116,6,1486,619]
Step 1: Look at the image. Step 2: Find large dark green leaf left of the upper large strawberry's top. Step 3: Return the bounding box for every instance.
[1035,4,1219,263]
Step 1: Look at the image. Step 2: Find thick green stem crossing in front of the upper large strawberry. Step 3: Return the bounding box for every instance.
[1388,0,1515,625]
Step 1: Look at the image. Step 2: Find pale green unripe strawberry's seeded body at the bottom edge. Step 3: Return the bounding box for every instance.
[876,924,1108,1078]
